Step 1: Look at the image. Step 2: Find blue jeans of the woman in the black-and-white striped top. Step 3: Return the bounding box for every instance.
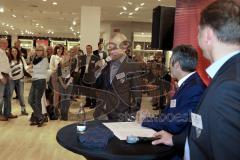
[10,79,25,108]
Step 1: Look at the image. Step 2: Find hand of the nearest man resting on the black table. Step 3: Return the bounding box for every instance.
[152,130,173,146]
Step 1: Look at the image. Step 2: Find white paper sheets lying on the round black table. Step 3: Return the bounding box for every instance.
[103,122,156,140]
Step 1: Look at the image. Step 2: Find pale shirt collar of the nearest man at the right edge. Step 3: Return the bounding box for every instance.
[206,50,240,78]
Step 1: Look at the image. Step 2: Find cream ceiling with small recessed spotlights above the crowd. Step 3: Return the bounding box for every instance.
[0,0,176,38]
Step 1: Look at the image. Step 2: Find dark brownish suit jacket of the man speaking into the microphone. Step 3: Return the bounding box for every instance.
[94,57,142,121]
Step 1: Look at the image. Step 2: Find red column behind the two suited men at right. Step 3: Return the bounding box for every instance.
[174,0,214,85]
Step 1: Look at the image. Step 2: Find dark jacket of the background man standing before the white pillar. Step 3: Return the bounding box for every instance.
[79,55,99,84]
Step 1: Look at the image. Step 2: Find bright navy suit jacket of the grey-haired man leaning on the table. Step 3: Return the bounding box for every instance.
[142,73,206,134]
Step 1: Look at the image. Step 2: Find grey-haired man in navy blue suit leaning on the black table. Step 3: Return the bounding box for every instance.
[142,45,206,134]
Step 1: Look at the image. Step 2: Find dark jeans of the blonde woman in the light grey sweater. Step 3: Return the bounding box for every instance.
[28,79,46,121]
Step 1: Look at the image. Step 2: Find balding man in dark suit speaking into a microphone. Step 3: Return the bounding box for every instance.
[94,33,141,121]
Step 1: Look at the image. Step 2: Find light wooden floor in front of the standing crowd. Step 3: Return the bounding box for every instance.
[0,83,155,160]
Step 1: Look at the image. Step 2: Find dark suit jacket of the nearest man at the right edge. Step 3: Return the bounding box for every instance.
[173,53,240,160]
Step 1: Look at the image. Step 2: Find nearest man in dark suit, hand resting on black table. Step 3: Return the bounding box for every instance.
[152,0,240,160]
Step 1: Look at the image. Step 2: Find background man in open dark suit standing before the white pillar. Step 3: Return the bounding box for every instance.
[80,45,99,108]
